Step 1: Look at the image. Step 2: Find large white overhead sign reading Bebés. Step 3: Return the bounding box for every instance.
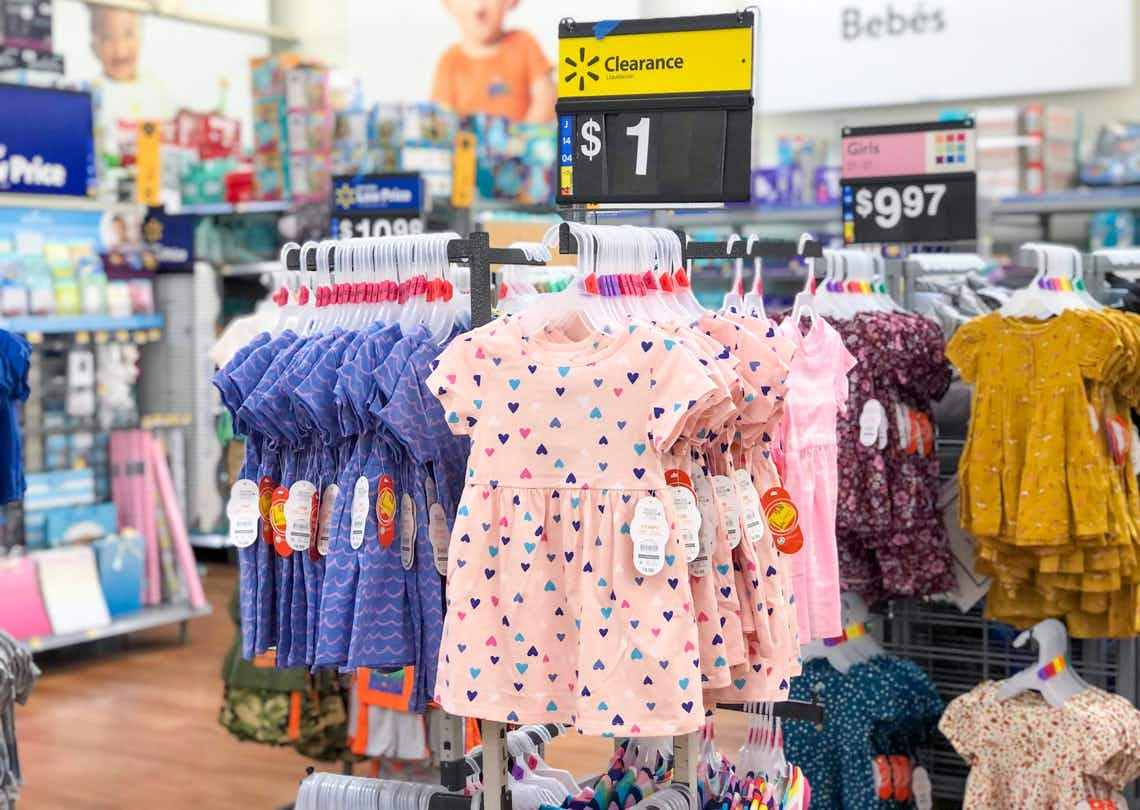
[758,0,1134,113]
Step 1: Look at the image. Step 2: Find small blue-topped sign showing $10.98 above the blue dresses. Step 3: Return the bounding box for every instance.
[331,172,424,239]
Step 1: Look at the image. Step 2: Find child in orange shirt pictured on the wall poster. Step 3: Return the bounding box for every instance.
[431,0,555,123]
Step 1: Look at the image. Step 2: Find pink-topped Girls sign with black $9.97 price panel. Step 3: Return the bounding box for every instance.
[841,120,978,244]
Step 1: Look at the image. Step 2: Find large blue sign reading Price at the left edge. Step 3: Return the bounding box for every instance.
[0,84,96,197]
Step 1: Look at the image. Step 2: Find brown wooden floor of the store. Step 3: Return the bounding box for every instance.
[16,565,742,810]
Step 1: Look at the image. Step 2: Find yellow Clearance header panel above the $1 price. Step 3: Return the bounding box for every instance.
[559,27,752,98]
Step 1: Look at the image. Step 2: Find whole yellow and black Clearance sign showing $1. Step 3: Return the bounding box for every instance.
[557,11,752,205]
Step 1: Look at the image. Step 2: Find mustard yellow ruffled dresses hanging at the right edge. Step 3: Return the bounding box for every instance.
[946,310,1140,638]
